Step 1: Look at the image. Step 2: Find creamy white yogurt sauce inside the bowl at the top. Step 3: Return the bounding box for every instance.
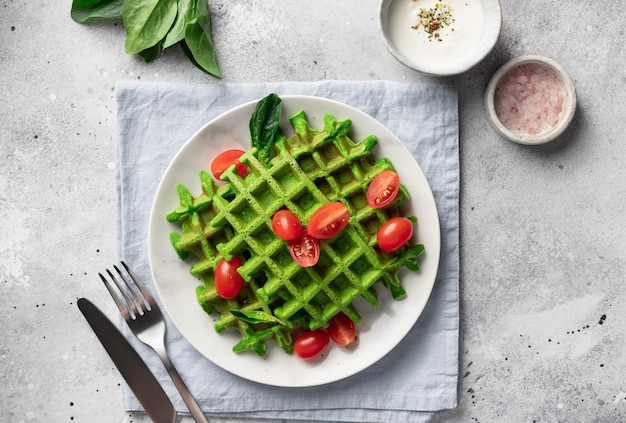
[388,0,484,72]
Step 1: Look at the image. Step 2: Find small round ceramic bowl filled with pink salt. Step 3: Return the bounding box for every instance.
[485,55,576,145]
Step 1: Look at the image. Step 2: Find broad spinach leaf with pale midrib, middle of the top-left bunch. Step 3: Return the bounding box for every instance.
[122,0,177,54]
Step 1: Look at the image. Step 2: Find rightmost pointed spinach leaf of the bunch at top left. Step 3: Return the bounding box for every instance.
[185,0,222,78]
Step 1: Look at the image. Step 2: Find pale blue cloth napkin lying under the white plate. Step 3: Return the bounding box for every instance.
[116,81,459,423]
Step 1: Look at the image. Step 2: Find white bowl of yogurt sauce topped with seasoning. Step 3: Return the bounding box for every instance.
[379,0,502,76]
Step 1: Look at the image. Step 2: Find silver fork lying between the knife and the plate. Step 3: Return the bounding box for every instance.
[99,261,208,423]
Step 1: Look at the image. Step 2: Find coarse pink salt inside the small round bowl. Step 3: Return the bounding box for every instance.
[494,64,565,135]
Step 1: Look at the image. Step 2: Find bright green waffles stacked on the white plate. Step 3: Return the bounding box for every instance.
[167,96,424,356]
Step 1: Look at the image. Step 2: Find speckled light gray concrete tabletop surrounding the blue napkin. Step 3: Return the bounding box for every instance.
[0,0,626,423]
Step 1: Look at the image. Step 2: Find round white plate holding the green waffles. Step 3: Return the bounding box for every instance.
[148,96,441,387]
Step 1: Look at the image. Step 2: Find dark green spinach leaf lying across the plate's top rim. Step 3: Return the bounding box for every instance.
[250,93,282,167]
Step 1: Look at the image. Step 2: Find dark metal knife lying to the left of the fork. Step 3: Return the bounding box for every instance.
[76,298,176,423]
